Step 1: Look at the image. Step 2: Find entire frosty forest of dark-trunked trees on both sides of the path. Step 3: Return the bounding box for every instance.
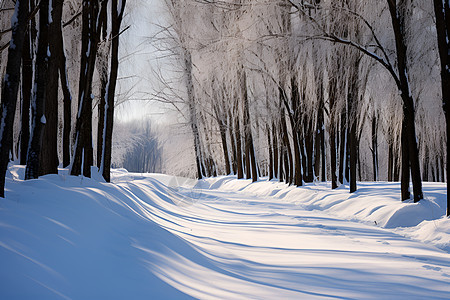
[0,0,450,215]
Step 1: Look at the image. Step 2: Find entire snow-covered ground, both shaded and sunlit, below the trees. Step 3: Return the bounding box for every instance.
[0,166,450,299]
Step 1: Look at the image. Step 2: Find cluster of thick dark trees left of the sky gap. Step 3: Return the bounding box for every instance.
[0,0,126,197]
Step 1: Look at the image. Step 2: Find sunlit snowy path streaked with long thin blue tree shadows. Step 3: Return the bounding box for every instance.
[149,184,450,299]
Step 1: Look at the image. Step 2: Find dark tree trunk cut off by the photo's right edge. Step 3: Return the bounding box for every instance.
[433,0,450,217]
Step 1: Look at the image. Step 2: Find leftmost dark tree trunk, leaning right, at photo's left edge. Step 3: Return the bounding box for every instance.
[0,0,28,198]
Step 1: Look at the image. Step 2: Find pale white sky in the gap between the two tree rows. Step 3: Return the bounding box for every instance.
[116,0,173,123]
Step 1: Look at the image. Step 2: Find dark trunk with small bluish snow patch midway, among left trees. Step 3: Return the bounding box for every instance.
[25,0,49,179]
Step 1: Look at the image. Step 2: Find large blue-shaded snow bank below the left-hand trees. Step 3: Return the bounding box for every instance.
[0,166,207,299]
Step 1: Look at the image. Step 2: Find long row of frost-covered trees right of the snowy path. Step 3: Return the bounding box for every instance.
[154,0,450,216]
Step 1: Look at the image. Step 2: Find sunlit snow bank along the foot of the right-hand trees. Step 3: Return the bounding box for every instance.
[198,176,450,252]
